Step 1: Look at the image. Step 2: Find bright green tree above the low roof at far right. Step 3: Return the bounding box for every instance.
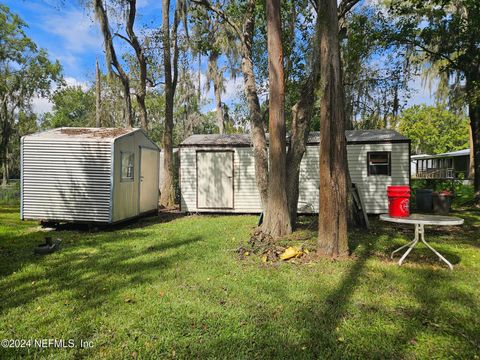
[399,105,469,154]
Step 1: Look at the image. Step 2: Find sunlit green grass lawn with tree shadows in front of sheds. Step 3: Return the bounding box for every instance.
[0,206,480,359]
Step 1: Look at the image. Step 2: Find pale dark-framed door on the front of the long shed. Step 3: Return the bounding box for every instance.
[197,151,233,209]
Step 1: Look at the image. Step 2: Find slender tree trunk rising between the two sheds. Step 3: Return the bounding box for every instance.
[160,0,178,208]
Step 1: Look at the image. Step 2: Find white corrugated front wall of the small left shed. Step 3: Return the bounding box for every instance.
[22,137,111,222]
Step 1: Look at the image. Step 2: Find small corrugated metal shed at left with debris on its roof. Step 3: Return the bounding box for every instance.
[21,128,159,223]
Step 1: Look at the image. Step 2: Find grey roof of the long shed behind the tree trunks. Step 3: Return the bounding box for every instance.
[180,130,408,146]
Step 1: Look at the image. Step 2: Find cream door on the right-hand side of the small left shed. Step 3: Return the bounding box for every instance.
[140,147,158,213]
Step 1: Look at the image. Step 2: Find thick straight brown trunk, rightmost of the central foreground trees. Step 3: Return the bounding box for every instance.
[318,0,348,257]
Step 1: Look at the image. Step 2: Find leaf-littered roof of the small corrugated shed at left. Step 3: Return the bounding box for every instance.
[25,127,140,142]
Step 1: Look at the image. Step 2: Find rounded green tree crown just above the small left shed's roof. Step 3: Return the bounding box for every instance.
[42,86,95,128]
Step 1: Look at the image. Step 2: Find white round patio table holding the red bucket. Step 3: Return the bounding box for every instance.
[380,214,464,270]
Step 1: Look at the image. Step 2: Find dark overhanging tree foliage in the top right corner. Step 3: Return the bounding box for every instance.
[388,0,480,107]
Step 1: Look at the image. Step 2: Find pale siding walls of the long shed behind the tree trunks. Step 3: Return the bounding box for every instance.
[180,143,410,214]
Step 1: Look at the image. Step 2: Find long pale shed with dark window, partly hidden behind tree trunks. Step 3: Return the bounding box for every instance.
[180,130,410,214]
